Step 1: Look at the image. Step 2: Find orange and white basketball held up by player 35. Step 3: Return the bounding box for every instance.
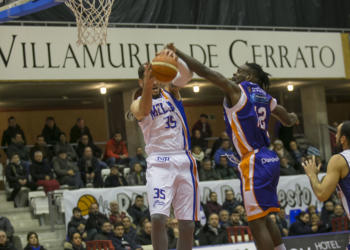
[151,55,178,83]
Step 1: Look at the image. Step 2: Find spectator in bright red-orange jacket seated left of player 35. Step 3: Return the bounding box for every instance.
[105,132,129,166]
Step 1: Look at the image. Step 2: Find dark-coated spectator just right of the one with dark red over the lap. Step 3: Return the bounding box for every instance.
[53,148,84,189]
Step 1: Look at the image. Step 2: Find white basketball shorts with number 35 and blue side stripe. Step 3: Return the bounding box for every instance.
[146,152,200,221]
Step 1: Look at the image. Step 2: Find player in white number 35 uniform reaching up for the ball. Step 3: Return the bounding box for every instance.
[131,50,200,250]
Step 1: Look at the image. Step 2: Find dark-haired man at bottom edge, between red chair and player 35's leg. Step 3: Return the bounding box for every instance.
[109,223,142,250]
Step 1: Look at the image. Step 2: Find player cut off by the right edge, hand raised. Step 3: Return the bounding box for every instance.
[303,121,350,250]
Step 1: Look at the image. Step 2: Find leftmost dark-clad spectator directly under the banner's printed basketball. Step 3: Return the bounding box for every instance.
[68,207,98,241]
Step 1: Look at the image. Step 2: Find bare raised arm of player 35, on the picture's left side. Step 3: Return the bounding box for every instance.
[130,63,155,121]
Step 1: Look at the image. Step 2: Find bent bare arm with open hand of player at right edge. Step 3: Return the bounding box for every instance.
[303,155,349,202]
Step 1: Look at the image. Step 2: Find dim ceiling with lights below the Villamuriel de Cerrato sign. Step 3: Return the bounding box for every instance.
[0,79,350,110]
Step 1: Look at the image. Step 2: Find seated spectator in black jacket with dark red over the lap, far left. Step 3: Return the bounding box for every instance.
[29,151,60,194]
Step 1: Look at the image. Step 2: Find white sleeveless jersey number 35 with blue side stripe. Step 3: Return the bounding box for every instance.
[139,89,191,155]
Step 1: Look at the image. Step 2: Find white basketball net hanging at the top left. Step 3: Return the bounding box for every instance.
[65,0,114,46]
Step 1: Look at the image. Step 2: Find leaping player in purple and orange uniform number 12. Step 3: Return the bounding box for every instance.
[167,44,299,250]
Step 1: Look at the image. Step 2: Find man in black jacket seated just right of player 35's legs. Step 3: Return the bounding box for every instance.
[198,214,229,246]
